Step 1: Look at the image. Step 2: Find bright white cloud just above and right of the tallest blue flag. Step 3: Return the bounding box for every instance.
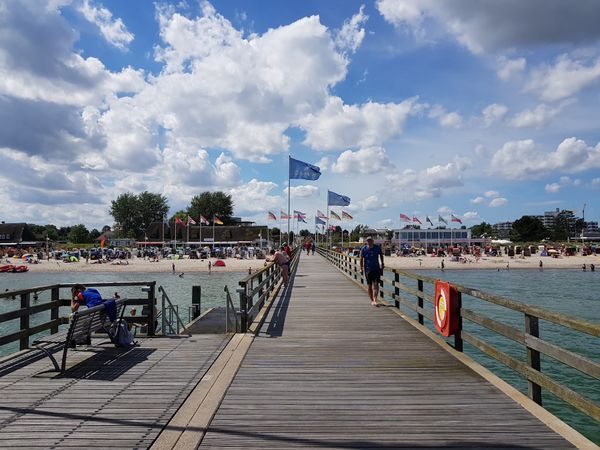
[298,97,417,150]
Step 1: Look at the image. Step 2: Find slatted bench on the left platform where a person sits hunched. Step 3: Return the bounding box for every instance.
[32,299,127,372]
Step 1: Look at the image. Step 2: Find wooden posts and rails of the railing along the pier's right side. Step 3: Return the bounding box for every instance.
[318,248,600,422]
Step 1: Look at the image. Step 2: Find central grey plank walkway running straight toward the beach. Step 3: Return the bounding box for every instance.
[201,255,573,449]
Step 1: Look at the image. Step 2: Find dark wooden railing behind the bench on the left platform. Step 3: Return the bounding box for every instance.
[0,281,156,350]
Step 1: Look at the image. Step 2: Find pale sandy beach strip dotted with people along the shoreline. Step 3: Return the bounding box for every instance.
[10,254,600,273]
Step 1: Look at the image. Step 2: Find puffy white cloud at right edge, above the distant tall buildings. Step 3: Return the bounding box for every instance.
[490,137,600,180]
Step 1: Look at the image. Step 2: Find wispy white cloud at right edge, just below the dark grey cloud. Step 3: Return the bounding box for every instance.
[526,54,600,101]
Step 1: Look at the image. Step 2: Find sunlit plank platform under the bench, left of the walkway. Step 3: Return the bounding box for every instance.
[0,335,229,449]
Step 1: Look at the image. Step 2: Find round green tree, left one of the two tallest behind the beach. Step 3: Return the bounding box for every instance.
[109,191,169,239]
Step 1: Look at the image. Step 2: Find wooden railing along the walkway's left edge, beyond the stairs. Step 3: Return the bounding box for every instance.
[237,247,300,333]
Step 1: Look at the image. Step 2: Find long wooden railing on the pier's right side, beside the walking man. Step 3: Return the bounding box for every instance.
[318,248,600,428]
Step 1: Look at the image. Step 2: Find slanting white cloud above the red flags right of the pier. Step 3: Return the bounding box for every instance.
[386,160,470,200]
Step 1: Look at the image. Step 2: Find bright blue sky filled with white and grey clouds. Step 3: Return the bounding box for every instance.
[0,0,600,227]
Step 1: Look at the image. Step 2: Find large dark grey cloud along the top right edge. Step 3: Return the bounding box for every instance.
[376,0,600,53]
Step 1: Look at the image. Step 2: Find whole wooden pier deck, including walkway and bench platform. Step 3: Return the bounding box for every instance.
[0,255,597,449]
